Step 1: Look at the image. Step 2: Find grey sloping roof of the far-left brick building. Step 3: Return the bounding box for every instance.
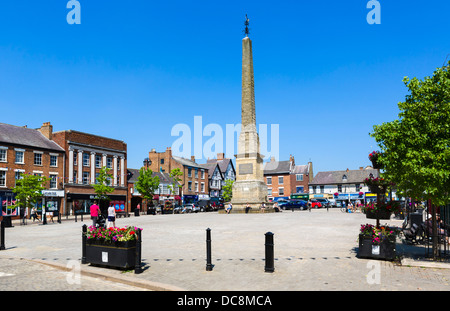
[0,123,64,152]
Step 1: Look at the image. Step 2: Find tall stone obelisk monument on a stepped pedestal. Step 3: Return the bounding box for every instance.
[231,18,268,212]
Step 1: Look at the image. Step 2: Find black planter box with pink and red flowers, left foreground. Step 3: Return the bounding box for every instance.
[85,240,139,269]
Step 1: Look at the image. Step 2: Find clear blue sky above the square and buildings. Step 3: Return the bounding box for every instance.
[0,0,450,173]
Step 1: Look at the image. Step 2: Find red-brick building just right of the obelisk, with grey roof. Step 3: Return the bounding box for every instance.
[264,155,313,201]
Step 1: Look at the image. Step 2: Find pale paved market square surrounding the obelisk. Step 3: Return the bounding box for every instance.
[0,208,450,291]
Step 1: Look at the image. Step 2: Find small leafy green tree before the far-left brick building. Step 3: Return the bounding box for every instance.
[12,174,50,216]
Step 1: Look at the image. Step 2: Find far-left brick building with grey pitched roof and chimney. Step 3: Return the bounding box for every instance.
[0,122,65,222]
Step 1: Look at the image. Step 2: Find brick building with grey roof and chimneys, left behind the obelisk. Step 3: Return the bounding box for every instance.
[144,147,209,203]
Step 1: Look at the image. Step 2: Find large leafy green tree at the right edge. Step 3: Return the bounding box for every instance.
[371,62,450,257]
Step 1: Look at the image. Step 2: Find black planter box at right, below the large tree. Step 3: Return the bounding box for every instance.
[358,234,395,260]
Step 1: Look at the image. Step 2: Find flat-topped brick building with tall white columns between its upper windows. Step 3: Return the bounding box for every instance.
[53,130,129,214]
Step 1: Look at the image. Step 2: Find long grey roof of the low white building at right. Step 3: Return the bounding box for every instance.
[309,169,378,185]
